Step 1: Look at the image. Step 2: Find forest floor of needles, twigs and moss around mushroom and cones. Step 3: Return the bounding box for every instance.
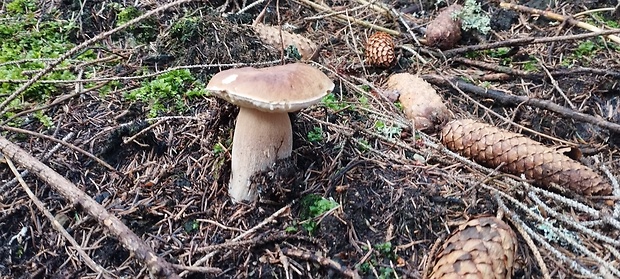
[0,0,620,278]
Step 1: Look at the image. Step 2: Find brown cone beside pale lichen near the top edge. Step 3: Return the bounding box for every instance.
[426,4,463,49]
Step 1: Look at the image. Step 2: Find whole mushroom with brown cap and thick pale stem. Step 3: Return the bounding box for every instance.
[206,63,334,202]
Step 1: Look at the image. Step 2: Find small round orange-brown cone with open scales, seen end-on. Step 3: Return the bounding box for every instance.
[365,32,396,68]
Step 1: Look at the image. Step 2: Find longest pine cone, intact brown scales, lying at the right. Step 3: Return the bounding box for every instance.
[441,119,612,195]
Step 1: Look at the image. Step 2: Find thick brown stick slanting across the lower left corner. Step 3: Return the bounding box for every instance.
[0,137,180,278]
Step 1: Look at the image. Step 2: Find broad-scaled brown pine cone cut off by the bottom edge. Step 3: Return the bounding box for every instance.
[429,217,517,279]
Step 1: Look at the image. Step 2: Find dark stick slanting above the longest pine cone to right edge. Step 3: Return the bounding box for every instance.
[422,75,620,133]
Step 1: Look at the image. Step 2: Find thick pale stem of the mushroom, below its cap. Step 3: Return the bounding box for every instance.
[228,107,293,202]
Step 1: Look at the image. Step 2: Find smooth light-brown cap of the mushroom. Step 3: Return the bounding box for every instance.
[207,63,334,112]
